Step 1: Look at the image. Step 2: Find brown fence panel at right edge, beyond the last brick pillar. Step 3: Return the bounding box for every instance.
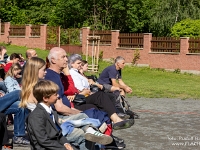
[188,37,200,53]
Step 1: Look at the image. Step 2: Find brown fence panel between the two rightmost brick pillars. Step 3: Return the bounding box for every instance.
[151,37,180,52]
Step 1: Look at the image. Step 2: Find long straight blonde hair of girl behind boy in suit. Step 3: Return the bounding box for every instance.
[19,57,46,108]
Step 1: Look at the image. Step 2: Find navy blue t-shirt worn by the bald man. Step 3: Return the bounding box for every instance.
[45,69,71,108]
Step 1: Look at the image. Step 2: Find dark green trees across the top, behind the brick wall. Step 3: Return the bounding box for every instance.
[0,0,200,36]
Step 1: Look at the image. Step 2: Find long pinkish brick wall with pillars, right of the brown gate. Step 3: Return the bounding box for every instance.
[82,27,200,74]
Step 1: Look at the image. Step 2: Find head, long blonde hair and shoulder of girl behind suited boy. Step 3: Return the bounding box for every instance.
[19,57,46,111]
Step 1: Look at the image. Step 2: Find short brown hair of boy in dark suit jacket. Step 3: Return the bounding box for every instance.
[33,80,59,103]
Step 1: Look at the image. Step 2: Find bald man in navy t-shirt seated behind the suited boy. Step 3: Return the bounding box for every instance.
[45,47,112,150]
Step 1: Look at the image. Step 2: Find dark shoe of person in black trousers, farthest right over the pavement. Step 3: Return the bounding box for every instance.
[113,119,134,130]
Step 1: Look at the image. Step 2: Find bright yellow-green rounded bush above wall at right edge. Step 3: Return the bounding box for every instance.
[171,19,200,37]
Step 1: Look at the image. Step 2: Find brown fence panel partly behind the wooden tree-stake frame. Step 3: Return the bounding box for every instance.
[89,30,111,44]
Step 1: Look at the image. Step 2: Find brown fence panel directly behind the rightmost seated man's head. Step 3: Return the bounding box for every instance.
[118,33,143,48]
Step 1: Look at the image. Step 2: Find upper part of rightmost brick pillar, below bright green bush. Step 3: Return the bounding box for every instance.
[180,37,189,55]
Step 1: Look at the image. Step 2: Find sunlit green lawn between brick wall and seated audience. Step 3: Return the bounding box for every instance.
[3,45,200,99]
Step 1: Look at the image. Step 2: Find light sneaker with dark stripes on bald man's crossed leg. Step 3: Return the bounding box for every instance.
[85,131,113,145]
